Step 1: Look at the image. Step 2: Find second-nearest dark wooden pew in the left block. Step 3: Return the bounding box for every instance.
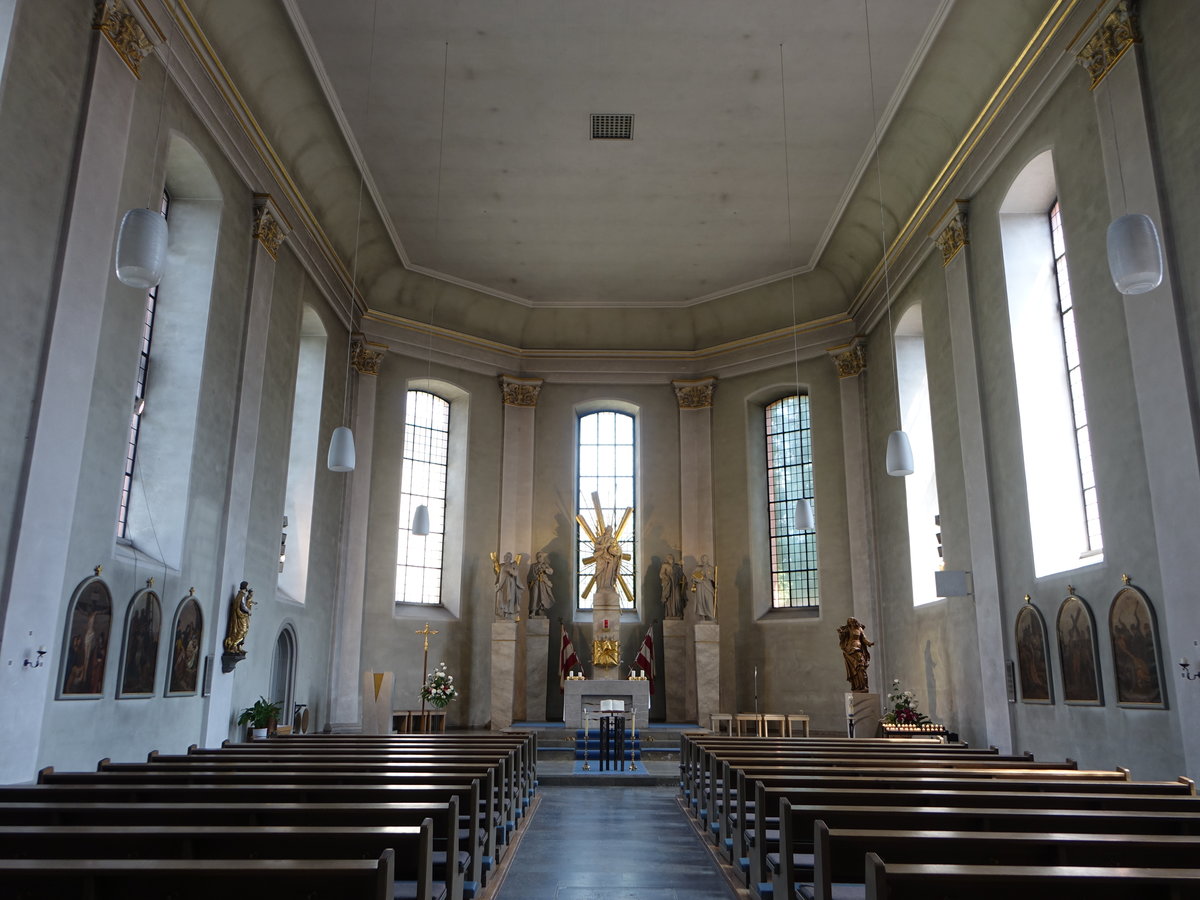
[0,818,446,900]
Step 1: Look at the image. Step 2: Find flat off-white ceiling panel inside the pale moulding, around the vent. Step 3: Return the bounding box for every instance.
[288,0,949,306]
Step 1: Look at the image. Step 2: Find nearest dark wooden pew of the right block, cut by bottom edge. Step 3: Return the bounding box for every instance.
[866,853,1200,900]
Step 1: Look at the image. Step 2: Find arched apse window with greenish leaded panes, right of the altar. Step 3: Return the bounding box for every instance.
[763,394,821,610]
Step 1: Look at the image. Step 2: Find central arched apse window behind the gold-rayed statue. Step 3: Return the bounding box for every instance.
[575,410,637,610]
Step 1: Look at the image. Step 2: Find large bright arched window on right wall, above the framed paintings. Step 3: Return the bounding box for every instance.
[1000,151,1103,577]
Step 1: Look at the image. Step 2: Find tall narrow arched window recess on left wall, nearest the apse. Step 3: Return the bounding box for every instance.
[278,305,325,604]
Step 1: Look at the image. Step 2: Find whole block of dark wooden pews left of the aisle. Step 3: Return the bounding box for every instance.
[0,734,536,900]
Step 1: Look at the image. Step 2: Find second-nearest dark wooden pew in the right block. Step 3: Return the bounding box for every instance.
[806,821,1200,900]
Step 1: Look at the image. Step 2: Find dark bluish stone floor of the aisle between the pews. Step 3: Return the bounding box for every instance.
[496,785,737,900]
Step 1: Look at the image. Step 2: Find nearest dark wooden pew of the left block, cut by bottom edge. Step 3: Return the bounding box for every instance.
[0,851,394,900]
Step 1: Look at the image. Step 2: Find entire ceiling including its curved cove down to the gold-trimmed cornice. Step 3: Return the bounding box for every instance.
[190,0,1070,350]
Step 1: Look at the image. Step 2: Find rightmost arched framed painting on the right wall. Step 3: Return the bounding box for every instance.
[1109,582,1166,709]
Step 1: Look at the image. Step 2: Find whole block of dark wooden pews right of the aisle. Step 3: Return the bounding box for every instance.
[679,732,1200,900]
